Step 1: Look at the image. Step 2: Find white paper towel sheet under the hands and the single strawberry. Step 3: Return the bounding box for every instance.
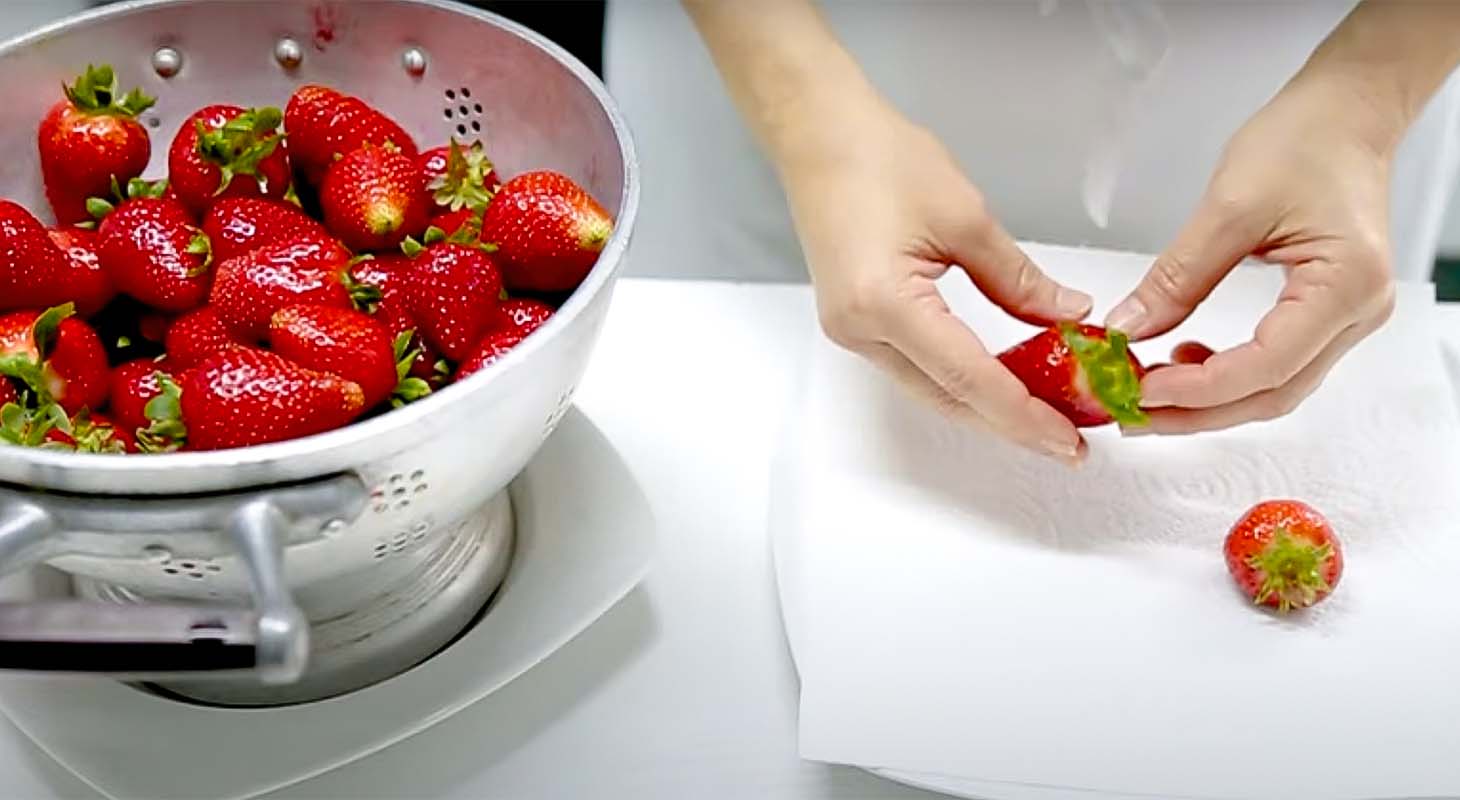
[772,247,1460,800]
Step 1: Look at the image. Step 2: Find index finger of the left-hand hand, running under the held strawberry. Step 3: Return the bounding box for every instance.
[888,293,1080,458]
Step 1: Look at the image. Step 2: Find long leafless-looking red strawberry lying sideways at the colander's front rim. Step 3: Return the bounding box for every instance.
[181,349,365,450]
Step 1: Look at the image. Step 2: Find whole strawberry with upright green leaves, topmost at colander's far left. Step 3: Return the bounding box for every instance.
[37,66,153,225]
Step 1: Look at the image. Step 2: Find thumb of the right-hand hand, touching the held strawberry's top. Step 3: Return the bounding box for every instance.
[1105,201,1263,339]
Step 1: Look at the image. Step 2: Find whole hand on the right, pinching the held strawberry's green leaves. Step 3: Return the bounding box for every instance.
[1107,82,1394,434]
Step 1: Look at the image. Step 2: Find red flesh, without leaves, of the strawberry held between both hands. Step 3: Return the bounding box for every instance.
[999,326,1146,428]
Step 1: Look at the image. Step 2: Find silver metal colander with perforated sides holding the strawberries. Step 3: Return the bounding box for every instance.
[0,0,638,702]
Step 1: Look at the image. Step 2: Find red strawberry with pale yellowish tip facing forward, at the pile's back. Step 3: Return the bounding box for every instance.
[320,145,428,251]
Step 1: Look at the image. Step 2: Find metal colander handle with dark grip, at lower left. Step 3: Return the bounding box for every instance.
[0,476,366,685]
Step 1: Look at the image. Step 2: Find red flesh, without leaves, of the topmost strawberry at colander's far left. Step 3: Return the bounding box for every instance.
[38,101,152,225]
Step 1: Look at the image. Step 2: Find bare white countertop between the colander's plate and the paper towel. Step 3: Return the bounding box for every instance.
[0,280,1460,800]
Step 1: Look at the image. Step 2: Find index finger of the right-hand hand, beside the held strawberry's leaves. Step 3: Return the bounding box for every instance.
[1140,278,1353,409]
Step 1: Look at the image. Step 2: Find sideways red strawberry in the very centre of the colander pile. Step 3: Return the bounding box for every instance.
[210,236,350,342]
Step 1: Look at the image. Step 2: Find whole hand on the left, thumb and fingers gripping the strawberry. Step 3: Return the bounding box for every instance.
[780,98,1091,464]
